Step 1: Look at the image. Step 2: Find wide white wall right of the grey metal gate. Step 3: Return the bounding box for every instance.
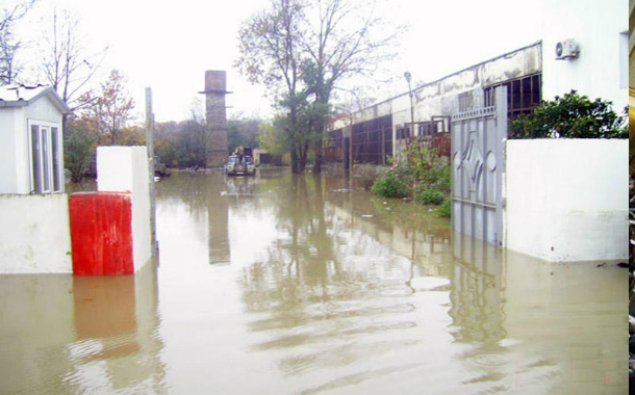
[504,139,628,262]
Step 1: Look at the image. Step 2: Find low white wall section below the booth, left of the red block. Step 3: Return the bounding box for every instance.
[0,194,73,274]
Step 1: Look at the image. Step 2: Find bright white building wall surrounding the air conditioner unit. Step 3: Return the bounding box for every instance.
[542,0,629,112]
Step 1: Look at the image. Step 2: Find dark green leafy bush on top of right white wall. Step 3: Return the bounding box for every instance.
[509,90,627,139]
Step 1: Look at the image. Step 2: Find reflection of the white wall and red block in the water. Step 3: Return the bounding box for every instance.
[0,262,164,393]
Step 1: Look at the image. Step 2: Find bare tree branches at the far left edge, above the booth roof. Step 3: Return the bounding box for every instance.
[0,0,36,85]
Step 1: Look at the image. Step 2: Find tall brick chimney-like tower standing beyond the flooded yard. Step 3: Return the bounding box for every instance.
[200,70,231,167]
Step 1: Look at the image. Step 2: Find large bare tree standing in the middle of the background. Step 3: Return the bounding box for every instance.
[237,0,401,172]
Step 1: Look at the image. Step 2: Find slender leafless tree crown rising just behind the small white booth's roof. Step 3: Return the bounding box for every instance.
[41,11,107,110]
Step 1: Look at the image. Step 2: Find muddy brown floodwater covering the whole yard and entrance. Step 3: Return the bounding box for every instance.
[0,171,628,394]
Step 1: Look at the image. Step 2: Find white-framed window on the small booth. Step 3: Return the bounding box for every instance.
[29,121,64,193]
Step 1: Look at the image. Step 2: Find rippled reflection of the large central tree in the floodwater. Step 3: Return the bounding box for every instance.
[241,174,428,375]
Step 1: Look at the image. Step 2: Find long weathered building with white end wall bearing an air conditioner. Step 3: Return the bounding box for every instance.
[327,0,630,164]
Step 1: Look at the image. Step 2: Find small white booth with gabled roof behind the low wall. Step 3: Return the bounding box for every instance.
[0,86,69,194]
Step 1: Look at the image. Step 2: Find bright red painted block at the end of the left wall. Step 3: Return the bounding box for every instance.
[69,192,134,276]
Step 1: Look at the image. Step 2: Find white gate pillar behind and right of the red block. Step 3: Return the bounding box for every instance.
[97,146,152,272]
